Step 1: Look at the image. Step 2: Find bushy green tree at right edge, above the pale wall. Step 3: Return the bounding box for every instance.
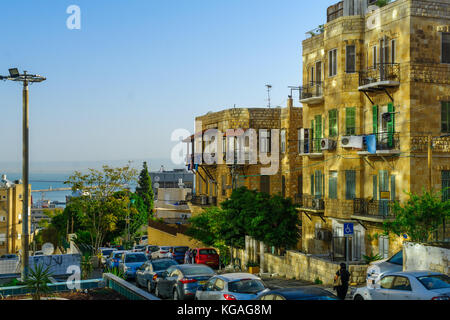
[384,190,450,243]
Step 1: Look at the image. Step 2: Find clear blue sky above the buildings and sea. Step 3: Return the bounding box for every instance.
[0,0,337,171]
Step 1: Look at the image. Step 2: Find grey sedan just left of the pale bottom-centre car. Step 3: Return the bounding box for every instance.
[155,264,216,300]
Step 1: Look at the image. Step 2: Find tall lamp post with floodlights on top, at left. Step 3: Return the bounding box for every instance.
[0,68,46,280]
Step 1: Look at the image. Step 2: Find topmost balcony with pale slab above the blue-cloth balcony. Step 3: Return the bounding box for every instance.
[358,63,400,92]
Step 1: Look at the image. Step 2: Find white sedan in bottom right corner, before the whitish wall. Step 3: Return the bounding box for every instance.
[353,271,450,300]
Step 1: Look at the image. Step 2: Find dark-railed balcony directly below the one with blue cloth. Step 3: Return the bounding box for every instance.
[352,198,395,222]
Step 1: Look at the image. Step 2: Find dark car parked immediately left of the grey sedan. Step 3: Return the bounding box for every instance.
[136,259,178,293]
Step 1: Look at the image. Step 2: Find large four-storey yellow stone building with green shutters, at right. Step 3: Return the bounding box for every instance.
[299,0,450,261]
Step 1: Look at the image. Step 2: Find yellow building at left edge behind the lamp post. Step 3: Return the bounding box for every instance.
[0,175,31,255]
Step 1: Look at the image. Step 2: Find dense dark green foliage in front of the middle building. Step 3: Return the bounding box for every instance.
[188,188,300,252]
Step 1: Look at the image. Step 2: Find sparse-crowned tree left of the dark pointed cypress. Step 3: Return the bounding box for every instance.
[65,165,136,252]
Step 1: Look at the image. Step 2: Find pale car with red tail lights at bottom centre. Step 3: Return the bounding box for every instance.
[195,273,270,300]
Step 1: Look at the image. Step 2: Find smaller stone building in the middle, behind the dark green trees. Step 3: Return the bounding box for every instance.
[185,96,302,222]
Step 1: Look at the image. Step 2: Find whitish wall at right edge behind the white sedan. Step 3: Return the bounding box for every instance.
[403,242,450,275]
